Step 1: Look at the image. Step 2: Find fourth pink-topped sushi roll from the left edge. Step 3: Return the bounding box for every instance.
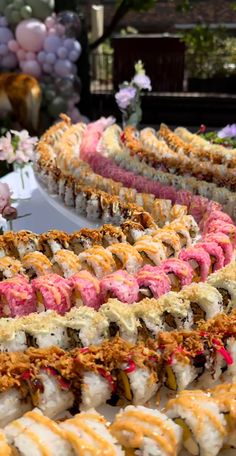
[100,269,139,304]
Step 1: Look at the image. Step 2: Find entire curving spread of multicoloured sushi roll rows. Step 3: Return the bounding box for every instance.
[0,115,236,456]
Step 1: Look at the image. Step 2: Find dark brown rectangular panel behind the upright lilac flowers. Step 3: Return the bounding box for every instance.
[112,35,185,92]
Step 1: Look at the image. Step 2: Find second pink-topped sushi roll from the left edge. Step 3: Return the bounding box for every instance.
[31,274,72,315]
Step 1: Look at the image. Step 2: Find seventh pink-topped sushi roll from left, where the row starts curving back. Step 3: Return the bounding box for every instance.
[179,246,211,282]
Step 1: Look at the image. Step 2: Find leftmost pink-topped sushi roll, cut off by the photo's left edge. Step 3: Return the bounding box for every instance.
[0,275,36,317]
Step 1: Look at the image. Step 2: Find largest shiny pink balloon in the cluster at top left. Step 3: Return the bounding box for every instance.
[16,19,47,52]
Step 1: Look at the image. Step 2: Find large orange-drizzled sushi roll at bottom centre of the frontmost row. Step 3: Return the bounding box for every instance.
[110,405,182,456]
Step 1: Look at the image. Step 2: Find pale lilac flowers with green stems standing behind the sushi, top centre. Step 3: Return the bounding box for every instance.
[115,60,152,127]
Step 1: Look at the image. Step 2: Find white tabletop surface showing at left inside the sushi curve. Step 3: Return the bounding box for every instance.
[1,165,86,233]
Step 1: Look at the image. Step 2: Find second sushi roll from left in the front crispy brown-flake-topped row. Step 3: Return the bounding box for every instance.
[22,366,75,418]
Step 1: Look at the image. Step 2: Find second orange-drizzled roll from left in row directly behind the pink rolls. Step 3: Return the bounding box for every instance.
[21,252,53,279]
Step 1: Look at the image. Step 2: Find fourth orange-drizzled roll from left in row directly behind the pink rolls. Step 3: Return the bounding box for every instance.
[79,246,117,279]
